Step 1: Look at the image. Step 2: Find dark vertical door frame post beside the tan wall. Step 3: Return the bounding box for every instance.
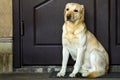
[12,0,22,68]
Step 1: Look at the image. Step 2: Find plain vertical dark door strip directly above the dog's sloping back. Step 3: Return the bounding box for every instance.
[95,0,109,51]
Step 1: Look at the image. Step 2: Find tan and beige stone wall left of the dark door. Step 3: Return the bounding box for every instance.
[0,0,12,72]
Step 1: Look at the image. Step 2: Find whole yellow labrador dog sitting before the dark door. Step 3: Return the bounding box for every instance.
[57,3,109,78]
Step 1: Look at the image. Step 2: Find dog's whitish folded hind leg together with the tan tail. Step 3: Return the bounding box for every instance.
[82,49,106,78]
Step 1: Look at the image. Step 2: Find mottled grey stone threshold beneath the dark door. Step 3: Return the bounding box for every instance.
[14,65,120,73]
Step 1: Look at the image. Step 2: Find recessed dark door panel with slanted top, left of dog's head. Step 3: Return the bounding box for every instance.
[33,0,63,46]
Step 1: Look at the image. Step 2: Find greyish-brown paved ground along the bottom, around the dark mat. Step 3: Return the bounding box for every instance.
[0,73,120,80]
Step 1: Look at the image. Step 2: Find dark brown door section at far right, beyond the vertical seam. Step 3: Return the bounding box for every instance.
[110,0,120,64]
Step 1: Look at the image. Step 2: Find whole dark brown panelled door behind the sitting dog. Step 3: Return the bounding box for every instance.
[14,0,120,66]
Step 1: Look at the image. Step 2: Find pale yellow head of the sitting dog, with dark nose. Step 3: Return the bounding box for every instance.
[64,3,84,22]
